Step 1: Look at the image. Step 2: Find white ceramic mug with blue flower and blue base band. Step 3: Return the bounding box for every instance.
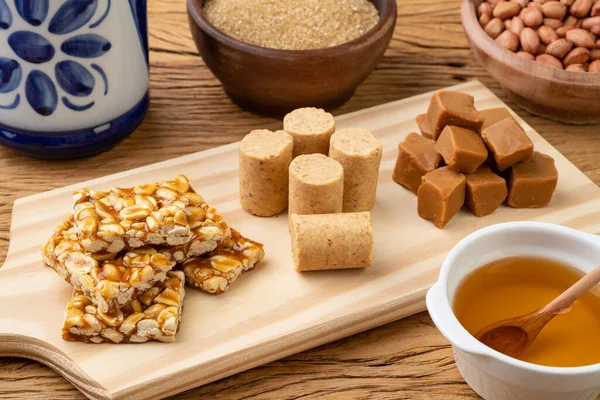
[0,0,149,158]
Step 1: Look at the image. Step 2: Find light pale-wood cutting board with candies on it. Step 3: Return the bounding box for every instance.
[0,81,600,399]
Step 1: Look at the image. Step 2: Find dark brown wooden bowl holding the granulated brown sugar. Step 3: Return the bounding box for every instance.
[187,0,396,115]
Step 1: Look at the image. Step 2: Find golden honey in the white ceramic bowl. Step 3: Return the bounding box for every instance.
[453,256,600,367]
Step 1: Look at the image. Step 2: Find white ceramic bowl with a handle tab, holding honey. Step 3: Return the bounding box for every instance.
[427,222,600,400]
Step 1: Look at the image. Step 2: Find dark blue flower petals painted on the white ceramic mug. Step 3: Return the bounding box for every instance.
[0,0,112,116]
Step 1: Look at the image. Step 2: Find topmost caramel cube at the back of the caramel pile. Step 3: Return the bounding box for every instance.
[427,90,483,140]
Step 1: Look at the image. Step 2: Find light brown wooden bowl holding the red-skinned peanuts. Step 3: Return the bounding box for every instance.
[461,0,600,125]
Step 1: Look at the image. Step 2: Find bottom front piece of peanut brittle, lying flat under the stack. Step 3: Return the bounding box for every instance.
[62,271,185,343]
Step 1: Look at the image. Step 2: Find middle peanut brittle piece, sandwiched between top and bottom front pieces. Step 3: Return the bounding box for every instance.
[42,215,175,313]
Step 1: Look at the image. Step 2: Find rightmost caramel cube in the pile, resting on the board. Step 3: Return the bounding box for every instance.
[508,151,558,208]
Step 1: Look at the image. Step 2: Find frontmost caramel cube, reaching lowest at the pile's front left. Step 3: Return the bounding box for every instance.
[417,167,466,229]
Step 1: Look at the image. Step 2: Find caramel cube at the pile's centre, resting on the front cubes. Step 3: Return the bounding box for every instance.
[435,125,488,174]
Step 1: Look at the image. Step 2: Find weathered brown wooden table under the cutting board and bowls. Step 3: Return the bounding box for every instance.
[0,0,600,400]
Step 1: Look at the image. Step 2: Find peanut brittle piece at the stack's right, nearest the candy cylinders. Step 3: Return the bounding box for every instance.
[182,230,265,294]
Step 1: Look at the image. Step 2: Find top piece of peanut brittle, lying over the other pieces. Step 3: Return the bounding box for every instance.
[73,175,230,256]
